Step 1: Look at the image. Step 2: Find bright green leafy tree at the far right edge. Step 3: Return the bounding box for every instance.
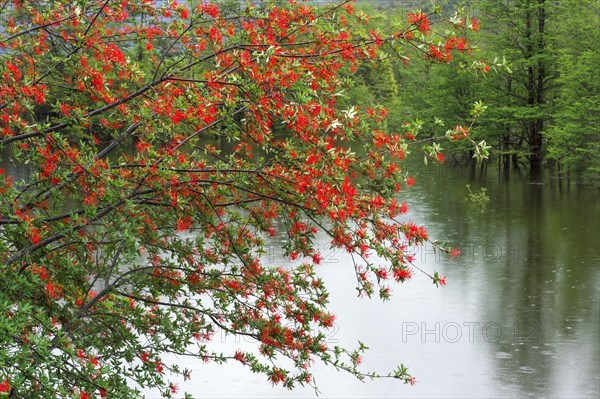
[546,0,600,180]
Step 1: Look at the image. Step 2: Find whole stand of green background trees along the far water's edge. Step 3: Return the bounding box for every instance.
[350,0,600,182]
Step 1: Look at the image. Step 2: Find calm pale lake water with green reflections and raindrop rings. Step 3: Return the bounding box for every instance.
[147,162,600,398]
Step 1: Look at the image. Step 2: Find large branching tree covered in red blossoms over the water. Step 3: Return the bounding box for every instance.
[0,0,478,399]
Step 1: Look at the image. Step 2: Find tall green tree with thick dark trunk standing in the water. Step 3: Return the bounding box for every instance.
[474,0,558,175]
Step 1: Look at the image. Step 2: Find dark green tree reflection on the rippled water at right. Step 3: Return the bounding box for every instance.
[410,161,600,396]
